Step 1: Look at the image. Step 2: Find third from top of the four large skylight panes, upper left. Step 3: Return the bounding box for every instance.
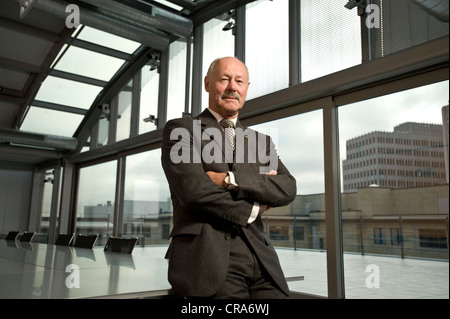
[36,76,103,110]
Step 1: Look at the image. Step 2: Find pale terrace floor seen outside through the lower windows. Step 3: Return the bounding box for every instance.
[133,246,449,299]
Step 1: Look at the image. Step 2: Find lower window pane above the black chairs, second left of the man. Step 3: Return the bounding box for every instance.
[75,161,117,246]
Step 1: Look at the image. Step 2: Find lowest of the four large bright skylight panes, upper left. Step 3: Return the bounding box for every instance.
[20,106,83,137]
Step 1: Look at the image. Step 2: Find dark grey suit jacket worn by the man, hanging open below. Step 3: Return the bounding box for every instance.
[162,110,296,297]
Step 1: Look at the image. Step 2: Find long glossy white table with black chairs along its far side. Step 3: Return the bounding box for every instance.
[0,239,171,299]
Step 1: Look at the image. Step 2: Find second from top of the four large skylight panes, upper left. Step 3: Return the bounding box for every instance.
[55,46,125,81]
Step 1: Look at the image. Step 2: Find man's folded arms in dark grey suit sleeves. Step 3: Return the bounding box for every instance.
[161,119,296,226]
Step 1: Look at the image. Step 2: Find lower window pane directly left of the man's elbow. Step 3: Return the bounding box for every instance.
[122,149,172,246]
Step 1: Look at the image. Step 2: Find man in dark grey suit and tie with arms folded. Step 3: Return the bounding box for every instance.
[162,57,296,299]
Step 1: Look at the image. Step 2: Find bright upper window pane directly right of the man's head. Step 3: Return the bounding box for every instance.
[245,0,289,99]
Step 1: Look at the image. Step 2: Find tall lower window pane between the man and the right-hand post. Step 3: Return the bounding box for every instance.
[252,111,328,296]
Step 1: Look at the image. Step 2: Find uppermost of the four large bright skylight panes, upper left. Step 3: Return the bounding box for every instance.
[77,26,141,54]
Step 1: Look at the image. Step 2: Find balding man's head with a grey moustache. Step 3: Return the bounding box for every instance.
[205,58,250,118]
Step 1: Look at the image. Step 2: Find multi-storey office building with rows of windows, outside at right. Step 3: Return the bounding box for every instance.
[342,123,448,192]
